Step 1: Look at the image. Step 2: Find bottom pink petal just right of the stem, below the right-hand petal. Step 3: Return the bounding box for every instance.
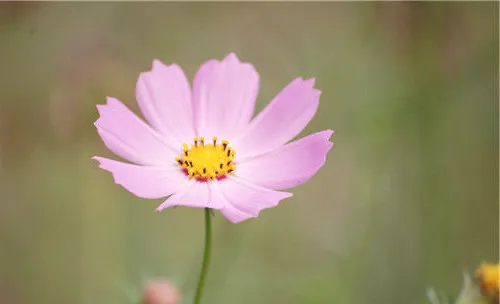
[219,177,293,223]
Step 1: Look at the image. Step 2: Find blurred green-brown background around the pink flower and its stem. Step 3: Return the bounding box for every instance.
[0,2,499,304]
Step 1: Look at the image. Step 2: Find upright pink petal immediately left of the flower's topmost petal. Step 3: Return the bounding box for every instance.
[136,60,195,147]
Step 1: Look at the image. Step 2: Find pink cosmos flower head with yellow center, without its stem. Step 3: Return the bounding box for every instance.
[94,53,333,223]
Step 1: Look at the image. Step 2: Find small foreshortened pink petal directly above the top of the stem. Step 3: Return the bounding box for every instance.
[156,179,221,211]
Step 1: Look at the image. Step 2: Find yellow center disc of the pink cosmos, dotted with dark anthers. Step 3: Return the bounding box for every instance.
[175,136,236,181]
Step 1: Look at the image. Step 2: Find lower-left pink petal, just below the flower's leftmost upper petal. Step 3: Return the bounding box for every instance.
[93,156,188,199]
